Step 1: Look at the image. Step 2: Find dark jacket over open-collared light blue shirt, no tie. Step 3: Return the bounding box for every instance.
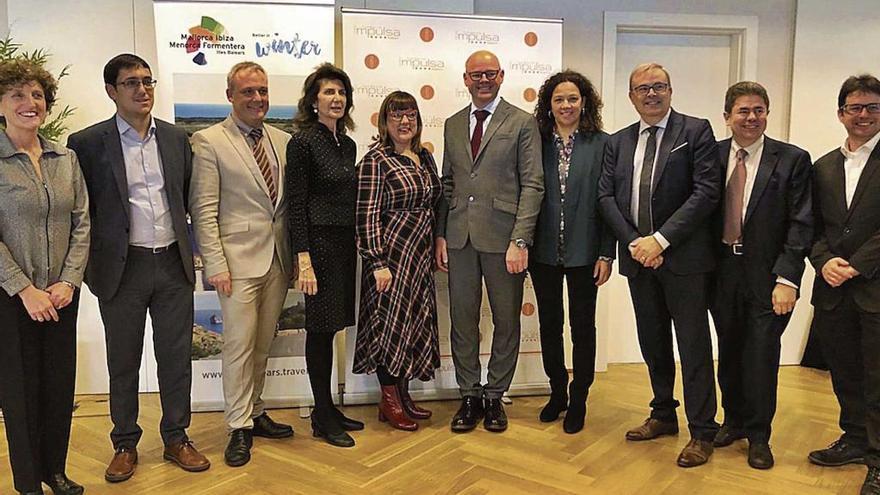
[67,115,195,299]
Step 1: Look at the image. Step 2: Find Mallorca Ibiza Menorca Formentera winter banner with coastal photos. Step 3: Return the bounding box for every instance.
[154,1,335,411]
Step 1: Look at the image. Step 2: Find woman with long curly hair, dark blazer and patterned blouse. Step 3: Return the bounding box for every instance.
[529,70,614,433]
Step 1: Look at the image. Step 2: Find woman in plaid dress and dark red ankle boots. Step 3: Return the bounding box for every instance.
[353,91,442,430]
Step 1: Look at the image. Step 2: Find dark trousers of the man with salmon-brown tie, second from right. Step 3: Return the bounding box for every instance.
[712,254,791,443]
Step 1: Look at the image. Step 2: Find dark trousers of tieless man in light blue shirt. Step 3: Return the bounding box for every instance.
[97,247,193,449]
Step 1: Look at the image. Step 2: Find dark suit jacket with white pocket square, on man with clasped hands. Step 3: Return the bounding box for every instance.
[599,110,722,277]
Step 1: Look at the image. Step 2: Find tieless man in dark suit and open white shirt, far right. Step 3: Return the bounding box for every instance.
[809,74,880,495]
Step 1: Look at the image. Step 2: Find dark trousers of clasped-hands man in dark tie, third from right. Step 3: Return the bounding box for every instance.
[629,267,718,441]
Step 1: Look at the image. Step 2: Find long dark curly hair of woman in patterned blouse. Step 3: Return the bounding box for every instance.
[535,70,602,138]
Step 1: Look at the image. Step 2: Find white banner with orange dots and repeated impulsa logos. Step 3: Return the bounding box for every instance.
[342,9,562,403]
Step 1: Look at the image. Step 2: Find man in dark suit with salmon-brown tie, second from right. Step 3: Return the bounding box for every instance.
[711,81,813,469]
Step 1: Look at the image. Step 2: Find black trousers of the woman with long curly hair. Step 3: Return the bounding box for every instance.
[529,262,598,404]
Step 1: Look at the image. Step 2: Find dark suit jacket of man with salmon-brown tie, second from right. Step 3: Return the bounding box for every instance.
[715,136,813,305]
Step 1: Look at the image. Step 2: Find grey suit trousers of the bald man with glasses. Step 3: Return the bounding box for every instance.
[448,242,525,399]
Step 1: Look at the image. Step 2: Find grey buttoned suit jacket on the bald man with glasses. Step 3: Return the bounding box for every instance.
[435,99,544,253]
